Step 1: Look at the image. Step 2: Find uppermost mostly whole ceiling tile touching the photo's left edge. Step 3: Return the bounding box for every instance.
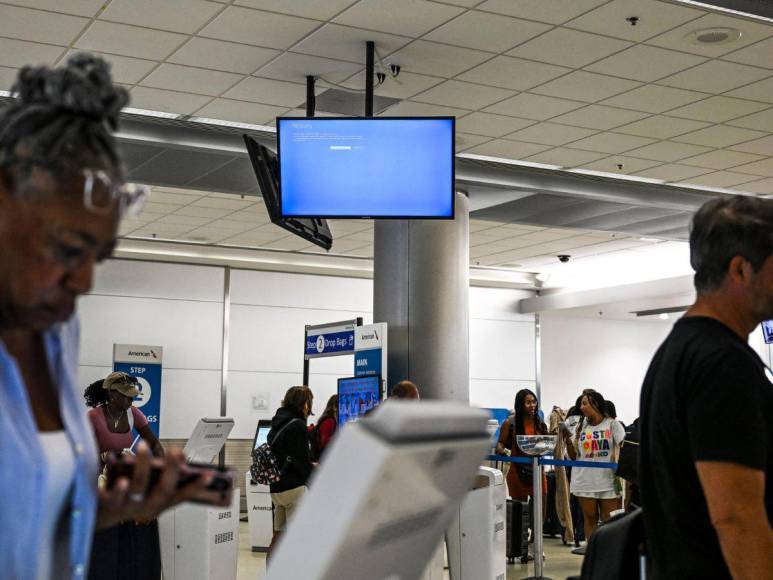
[0,4,89,46]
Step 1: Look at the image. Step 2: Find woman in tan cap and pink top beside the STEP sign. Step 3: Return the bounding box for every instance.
[83,372,164,580]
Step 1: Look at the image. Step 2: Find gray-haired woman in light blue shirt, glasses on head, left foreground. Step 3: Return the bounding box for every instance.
[0,54,230,580]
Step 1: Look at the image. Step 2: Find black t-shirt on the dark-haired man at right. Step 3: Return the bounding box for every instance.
[639,317,773,580]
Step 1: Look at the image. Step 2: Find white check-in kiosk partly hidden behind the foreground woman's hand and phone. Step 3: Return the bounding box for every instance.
[158,417,239,580]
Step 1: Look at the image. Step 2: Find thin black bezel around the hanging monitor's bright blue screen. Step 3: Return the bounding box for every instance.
[276,115,456,221]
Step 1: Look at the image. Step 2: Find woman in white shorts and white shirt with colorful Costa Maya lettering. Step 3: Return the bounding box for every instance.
[561,389,625,539]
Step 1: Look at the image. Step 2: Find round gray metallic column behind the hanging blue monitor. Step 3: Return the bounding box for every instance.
[373,193,470,402]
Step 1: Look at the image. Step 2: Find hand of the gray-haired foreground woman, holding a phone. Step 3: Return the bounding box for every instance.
[97,442,233,529]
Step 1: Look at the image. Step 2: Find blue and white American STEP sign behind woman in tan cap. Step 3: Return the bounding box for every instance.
[113,344,164,439]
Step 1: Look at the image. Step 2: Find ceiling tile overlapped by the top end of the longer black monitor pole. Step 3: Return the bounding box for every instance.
[293,24,411,64]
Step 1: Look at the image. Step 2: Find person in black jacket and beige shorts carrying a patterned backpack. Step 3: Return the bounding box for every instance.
[267,387,314,557]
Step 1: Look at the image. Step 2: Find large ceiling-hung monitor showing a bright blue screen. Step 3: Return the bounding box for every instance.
[276,117,455,219]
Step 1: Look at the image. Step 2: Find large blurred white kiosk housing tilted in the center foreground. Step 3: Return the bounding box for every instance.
[265,401,490,580]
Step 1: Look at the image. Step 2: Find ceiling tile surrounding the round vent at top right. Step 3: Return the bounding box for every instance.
[647,13,771,58]
